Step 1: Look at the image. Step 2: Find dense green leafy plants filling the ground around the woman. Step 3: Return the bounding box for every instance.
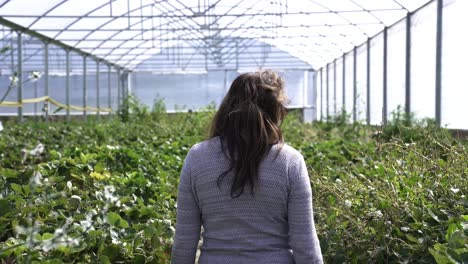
[0,106,468,263]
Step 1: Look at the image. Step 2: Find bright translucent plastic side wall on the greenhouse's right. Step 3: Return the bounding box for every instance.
[317,0,468,129]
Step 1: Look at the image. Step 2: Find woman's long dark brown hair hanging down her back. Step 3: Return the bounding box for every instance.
[210,70,286,198]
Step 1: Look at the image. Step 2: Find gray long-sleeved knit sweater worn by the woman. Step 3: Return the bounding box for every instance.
[172,137,323,264]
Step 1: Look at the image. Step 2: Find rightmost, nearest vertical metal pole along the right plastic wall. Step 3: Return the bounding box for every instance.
[435,0,444,126]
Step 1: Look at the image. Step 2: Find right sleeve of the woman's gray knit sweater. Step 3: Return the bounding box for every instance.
[288,155,323,264]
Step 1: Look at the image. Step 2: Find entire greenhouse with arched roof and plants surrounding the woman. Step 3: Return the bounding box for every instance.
[0,0,468,264]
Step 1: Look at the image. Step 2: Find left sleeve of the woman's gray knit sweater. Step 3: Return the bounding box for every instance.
[171,148,201,264]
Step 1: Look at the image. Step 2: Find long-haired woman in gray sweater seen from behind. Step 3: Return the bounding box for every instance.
[172,71,323,264]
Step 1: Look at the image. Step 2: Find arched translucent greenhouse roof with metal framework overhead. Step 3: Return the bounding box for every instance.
[0,0,431,69]
